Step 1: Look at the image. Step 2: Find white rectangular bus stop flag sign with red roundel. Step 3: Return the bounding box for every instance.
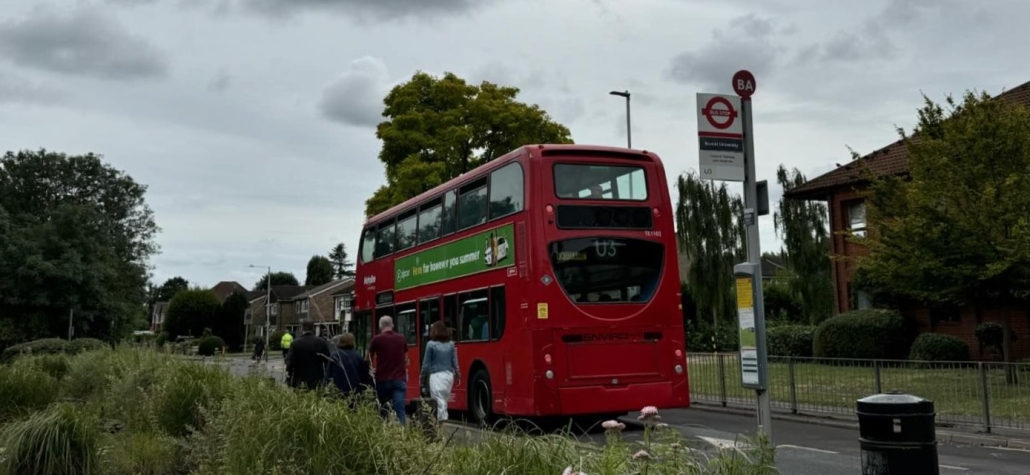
[697,93,745,181]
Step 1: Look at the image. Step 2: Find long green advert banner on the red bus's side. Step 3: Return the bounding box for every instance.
[393,225,515,291]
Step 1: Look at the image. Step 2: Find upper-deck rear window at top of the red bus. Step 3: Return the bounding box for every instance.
[554,163,648,201]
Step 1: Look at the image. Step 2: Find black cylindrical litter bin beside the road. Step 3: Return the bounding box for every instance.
[856,393,940,475]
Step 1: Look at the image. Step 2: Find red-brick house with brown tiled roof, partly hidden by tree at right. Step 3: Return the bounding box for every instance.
[784,78,1030,360]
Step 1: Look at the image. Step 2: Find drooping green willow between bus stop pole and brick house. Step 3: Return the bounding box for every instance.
[774,165,833,325]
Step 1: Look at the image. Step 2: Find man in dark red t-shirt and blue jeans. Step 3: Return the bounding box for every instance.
[369,315,408,426]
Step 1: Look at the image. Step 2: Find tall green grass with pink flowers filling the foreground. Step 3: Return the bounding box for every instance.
[0,348,774,475]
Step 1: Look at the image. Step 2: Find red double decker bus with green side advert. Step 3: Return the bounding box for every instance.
[350,145,689,420]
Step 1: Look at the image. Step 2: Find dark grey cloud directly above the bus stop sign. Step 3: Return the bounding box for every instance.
[666,14,792,90]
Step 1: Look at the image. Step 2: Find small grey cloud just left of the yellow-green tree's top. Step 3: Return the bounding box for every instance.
[318,57,388,127]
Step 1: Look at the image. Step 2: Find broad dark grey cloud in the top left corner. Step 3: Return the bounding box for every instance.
[0,6,168,80]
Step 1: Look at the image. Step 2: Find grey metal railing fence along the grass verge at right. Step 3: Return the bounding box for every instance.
[687,353,1030,432]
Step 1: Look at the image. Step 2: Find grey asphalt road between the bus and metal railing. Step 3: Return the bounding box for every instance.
[626,409,1030,475]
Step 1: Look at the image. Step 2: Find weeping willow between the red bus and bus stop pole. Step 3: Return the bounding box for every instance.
[676,168,747,329]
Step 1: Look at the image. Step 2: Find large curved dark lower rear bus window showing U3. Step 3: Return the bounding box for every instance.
[549,237,664,304]
